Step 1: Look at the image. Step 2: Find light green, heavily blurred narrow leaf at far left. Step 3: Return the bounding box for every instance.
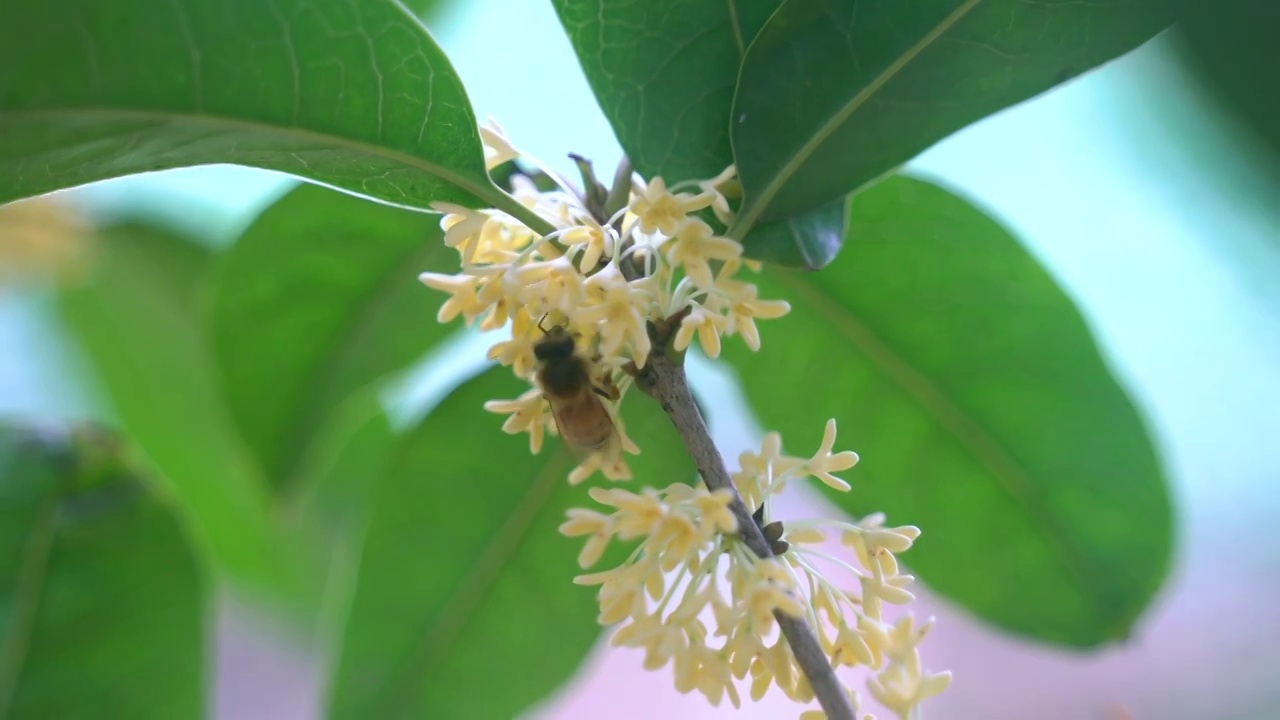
[59,224,302,600]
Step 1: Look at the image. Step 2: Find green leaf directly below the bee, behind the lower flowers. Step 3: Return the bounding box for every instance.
[330,368,694,717]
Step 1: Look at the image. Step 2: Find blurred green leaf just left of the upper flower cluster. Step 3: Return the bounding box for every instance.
[212,184,457,489]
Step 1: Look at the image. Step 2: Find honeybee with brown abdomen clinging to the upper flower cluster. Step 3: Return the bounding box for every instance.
[534,324,616,452]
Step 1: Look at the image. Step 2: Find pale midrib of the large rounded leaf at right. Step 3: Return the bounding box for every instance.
[774,273,1108,620]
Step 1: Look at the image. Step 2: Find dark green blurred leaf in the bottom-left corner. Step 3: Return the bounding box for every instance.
[0,425,207,719]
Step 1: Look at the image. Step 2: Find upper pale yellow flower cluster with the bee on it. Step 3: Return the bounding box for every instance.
[420,124,790,480]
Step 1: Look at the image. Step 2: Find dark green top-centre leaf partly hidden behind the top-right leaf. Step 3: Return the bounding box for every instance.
[553,0,845,270]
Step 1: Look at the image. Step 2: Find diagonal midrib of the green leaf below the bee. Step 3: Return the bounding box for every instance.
[373,450,571,712]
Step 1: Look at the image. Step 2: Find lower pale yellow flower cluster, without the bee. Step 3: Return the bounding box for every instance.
[561,420,951,720]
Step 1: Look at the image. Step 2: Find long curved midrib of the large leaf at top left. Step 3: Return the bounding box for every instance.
[0,105,494,210]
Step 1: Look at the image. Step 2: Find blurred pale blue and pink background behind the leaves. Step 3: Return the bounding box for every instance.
[0,0,1280,720]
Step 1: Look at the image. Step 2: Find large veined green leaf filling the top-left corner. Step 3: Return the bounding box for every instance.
[0,0,506,208]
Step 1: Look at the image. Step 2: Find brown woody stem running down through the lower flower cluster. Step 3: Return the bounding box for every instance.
[636,348,855,720]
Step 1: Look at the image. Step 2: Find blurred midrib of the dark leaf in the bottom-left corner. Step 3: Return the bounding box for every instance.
[0,492,61,717]
